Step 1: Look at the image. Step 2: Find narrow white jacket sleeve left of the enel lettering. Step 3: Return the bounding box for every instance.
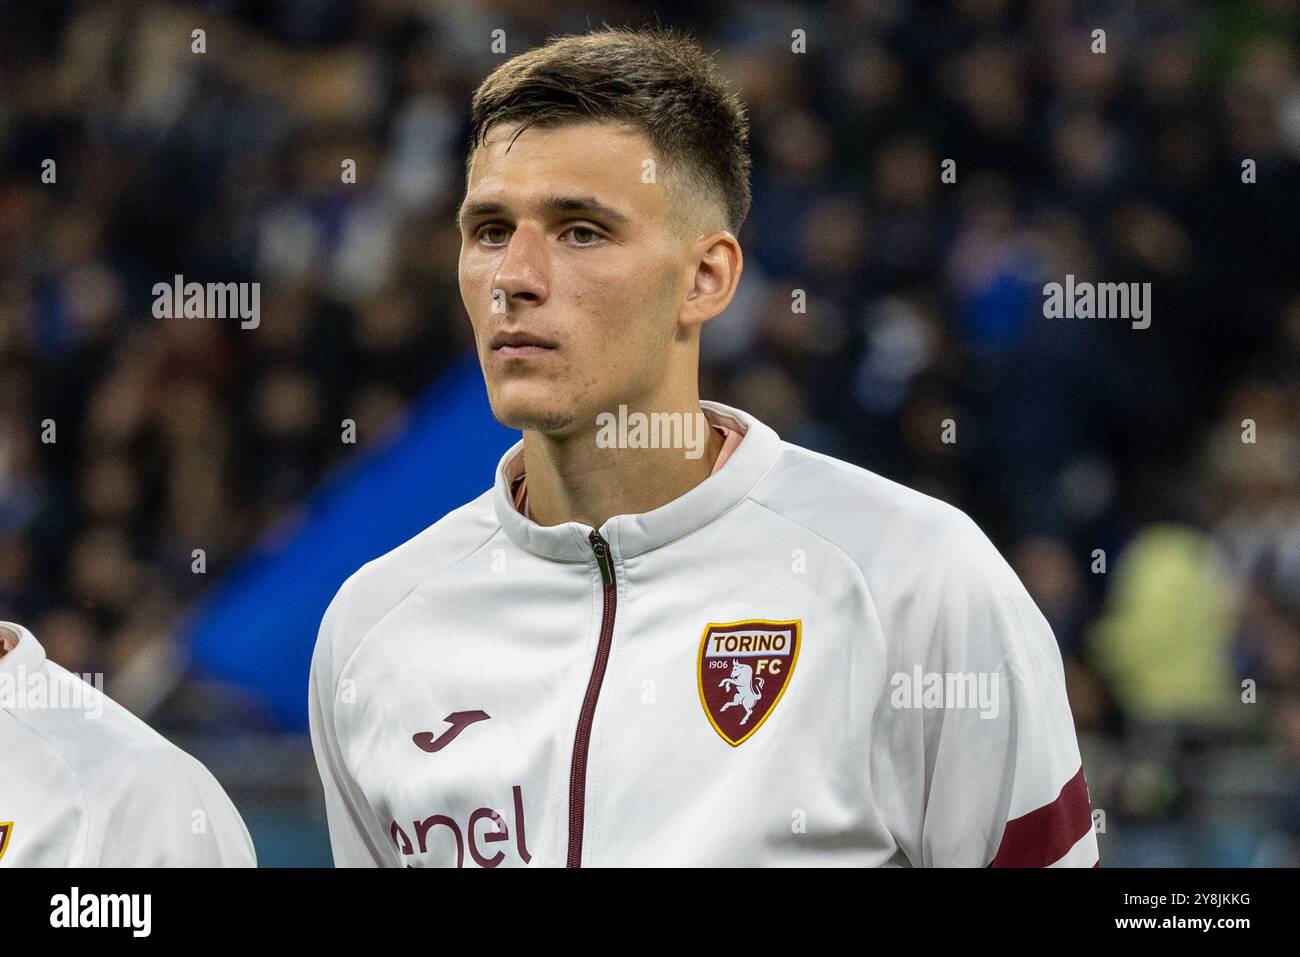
[307,579,397,867]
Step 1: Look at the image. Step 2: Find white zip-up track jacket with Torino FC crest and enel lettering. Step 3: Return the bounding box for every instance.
[309,402,1099,867]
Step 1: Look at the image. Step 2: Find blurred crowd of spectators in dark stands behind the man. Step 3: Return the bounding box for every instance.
[0,0,1300,865]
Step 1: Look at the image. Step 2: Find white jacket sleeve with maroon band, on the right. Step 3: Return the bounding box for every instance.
[878,515,1100,867]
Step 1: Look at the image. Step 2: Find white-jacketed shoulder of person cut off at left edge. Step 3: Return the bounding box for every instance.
[0,622,257,867]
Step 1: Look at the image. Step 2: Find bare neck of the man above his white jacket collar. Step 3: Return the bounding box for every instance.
[524,400,723,528]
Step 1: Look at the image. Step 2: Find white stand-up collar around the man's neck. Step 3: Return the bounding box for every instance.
[493,400,781,562]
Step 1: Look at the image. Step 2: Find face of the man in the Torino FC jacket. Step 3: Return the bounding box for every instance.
[460,122,694,434]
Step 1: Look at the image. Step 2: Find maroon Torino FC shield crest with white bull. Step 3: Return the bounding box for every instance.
[699,619,801,746]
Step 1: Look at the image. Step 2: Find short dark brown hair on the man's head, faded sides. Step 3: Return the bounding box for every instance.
[467,26,750,233]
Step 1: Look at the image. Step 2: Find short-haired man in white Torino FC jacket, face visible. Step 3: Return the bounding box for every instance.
[309,30,1097,867]
